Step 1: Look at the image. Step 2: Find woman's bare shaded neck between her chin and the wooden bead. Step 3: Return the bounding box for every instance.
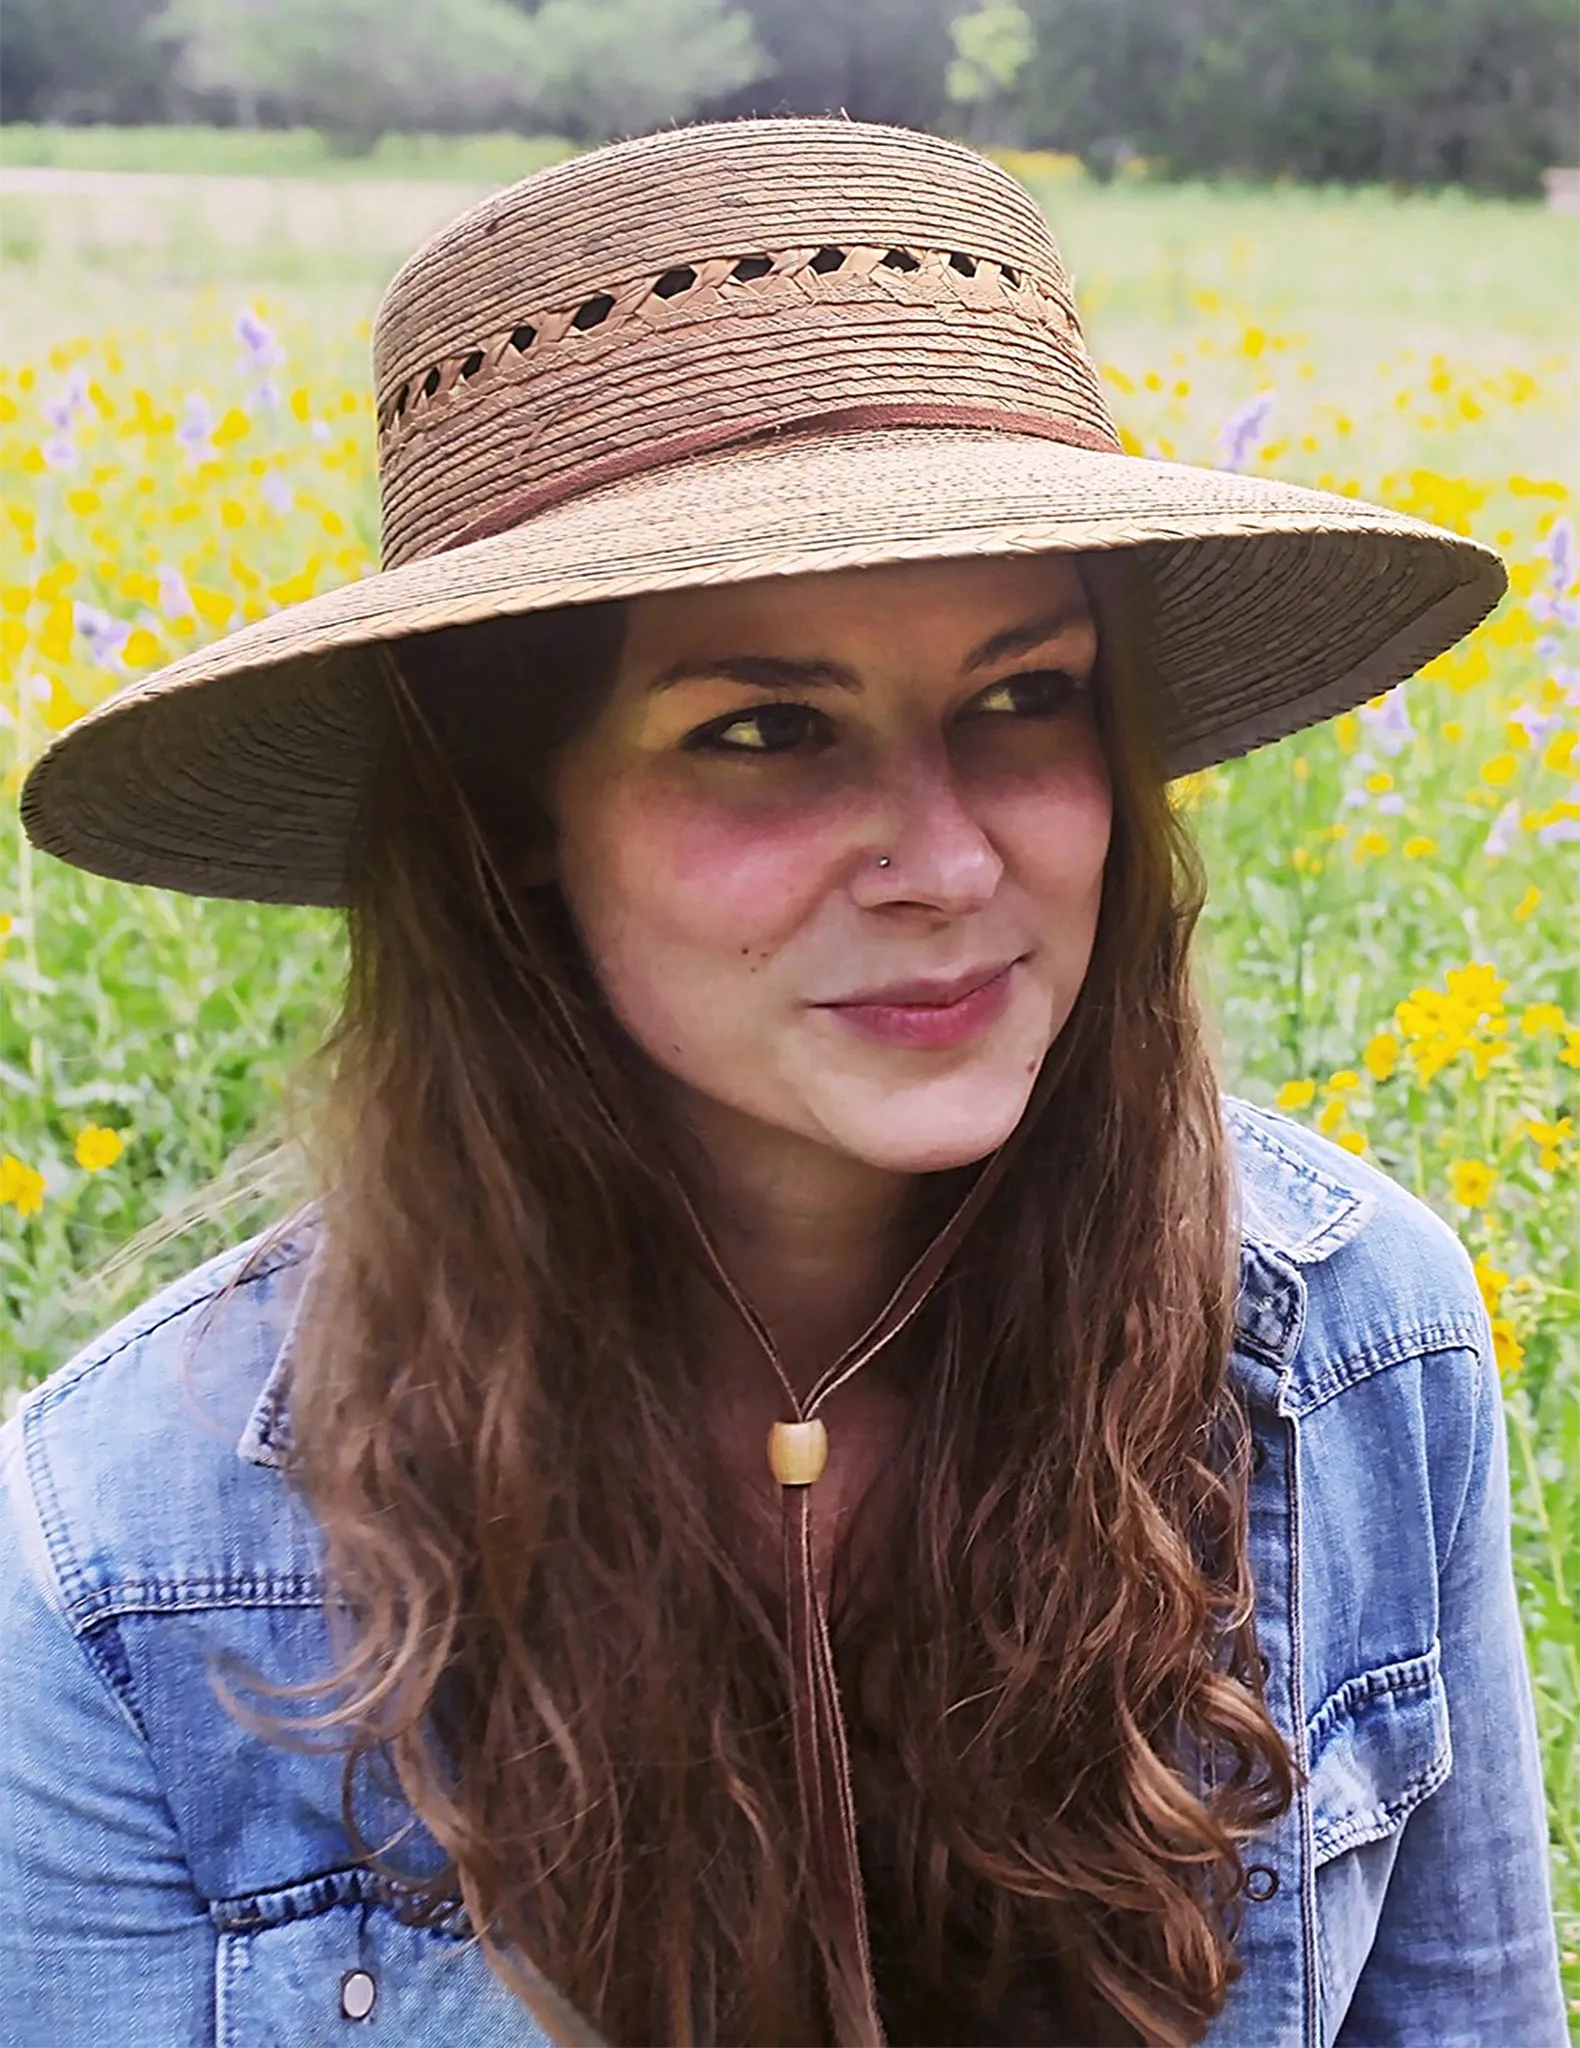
[672,1102,918,1391]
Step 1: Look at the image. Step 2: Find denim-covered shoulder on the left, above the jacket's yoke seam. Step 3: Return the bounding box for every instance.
[0,1219,314,1628]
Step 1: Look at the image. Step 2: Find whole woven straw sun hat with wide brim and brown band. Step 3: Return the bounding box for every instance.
[23,119,1506,903]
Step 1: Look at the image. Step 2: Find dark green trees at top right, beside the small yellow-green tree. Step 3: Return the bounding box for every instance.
[1021,0,1580,193]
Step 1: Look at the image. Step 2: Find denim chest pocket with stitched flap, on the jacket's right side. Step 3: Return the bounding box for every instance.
[1307,1642,1453,2042]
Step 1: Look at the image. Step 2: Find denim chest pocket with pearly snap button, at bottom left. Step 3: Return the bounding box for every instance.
[215,1874,557,2048]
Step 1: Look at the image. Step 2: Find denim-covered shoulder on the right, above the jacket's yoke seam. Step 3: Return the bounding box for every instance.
[1223,1096,1488,1407]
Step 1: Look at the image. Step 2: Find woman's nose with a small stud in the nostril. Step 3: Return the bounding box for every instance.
[850,745,1004,918]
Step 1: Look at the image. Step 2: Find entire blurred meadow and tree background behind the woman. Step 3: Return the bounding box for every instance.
[0,0,1580,2038]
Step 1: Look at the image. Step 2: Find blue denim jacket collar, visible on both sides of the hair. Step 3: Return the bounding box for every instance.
[236,1096,1377,1466]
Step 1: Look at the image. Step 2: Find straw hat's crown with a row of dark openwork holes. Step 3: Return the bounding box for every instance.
[373,119,1119,567]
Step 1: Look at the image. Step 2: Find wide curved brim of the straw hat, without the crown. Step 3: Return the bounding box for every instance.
[23,426,1506,905]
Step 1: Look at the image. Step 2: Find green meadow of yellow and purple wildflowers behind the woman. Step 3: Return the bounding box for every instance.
[0,162,1580,2015]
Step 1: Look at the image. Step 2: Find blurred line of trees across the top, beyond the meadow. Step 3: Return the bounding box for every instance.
[0,0,1580,193]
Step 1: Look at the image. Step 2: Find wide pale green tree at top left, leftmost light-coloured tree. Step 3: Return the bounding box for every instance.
[154,0,537,150]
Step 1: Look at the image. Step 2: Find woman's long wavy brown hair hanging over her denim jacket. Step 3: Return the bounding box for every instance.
[234,557,1297,2048]
